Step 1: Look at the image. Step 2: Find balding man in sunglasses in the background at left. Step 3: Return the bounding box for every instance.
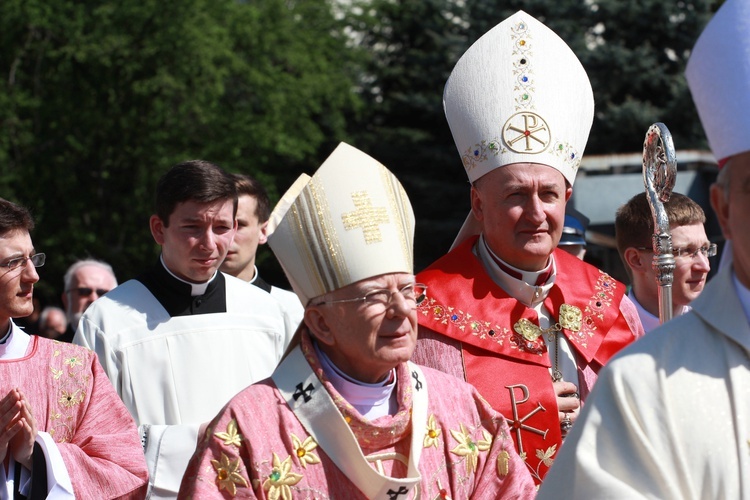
[58,259,117,342]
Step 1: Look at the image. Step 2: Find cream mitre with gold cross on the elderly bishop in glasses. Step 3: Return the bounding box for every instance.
[268,143,414,305]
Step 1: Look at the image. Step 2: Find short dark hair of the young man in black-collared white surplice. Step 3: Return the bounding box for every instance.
[156,160,237,227]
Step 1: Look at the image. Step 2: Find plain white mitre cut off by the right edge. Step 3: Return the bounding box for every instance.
[685,0,750,163]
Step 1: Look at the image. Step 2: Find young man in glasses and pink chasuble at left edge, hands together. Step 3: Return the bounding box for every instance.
[0,199,148,499]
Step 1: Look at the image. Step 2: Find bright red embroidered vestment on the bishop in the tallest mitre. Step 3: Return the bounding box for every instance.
[414,237,636,483]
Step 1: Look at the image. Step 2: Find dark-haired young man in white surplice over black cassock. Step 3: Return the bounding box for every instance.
[74,160,296,498]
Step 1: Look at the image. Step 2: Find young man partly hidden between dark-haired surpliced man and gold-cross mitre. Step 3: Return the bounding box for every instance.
[221,174,305,325]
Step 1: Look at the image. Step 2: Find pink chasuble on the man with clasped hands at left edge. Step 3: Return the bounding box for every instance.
[0,325,148,499]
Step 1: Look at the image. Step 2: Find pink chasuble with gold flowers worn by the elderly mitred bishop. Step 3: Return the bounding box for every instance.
[180,332,535,500]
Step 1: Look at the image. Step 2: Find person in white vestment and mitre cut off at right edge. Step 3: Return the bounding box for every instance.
[538,0,750,500]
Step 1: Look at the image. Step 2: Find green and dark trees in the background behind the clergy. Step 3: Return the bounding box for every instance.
[0,0,721,306]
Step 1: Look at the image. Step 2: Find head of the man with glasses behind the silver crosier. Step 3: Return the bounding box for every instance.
[615,192,716,333]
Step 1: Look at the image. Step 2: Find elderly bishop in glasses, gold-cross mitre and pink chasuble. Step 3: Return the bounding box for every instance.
[180,144,534,500]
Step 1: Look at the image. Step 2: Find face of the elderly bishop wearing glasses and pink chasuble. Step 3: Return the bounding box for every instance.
[305,273,417,383]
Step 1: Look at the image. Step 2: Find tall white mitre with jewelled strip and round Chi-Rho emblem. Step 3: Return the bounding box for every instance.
[443,11,594,246]
